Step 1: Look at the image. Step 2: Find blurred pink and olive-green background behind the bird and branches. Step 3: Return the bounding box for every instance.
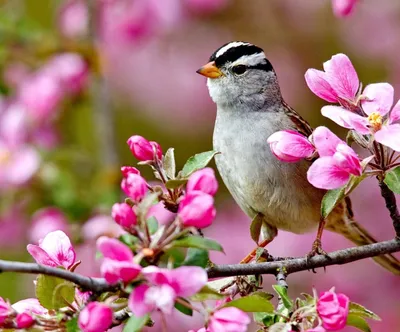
[0,0,400,332]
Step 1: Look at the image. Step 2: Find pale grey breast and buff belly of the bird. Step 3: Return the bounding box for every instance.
[213,109,323,233]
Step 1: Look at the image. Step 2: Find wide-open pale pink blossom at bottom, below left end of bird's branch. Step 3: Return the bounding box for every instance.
[128,266,207,316]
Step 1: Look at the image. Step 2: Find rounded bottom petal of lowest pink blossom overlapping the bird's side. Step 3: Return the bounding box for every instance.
[307,157,350,190]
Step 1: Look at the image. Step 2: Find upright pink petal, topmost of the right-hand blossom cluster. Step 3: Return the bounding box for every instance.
[324,53,360,100]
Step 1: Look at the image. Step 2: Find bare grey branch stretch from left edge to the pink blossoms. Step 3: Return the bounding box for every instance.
[0,260,120,294]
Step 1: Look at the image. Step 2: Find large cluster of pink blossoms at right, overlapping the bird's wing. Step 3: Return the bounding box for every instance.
[268,54,400,189]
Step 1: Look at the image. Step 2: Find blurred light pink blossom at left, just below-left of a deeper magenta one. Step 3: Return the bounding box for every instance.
[19,72,64,122]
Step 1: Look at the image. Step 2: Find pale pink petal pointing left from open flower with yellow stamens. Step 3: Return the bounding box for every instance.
[321,106,370,135]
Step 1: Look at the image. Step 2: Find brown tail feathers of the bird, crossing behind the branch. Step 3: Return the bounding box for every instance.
[335,221,400,275]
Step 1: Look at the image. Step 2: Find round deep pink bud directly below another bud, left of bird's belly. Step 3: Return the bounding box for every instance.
[178,191,216,228]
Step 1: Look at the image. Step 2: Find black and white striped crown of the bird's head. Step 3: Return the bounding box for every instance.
[210,41,273,71]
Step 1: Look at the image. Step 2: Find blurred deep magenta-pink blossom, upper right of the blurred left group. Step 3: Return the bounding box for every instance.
[43,53,89,93]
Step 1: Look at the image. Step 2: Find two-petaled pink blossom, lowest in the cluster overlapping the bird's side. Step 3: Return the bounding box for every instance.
[307,127,362,189]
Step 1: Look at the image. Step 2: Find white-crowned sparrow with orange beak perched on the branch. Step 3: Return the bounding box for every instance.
[197,41,400,275]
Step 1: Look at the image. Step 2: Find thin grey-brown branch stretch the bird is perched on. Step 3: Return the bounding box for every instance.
[207,239,400,278]
